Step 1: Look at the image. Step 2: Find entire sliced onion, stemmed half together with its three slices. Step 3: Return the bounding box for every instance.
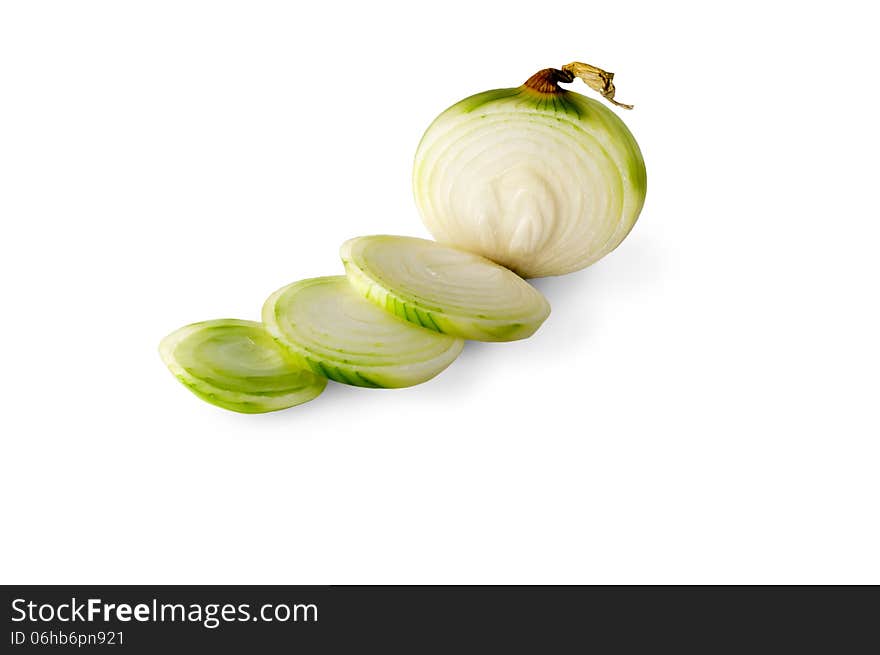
[159,63,646,413]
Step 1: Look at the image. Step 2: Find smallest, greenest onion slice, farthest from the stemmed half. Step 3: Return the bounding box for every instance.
[159,319,327,414]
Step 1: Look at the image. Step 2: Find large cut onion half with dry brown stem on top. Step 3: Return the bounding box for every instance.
[413,63,646,277]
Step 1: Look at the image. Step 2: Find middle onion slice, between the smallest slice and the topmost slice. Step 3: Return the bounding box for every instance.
[263,275,464,388]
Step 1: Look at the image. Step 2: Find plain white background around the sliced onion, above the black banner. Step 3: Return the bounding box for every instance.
[0,0,880,583]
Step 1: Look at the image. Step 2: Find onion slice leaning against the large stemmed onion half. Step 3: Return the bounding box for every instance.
[340,235,550,341]
